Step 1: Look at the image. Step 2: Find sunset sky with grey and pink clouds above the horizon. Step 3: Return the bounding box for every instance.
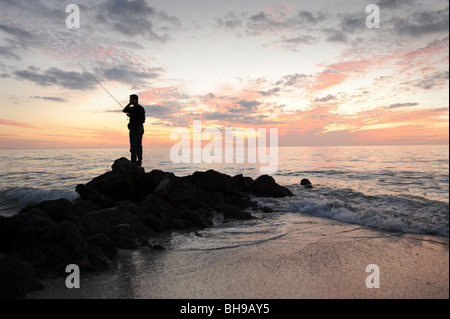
[0,0,449,149]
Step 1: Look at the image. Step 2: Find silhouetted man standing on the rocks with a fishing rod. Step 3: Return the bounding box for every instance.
[123,94,145,166]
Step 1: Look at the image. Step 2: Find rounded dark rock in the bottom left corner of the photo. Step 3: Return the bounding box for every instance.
[0,256,43,299]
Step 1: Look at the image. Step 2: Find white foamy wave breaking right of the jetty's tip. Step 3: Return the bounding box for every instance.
[255,187,449,236]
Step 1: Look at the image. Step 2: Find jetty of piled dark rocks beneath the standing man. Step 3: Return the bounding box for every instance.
[0,158,292,298]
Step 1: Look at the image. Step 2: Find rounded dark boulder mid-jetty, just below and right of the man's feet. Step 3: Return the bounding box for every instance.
[136,194,175,231]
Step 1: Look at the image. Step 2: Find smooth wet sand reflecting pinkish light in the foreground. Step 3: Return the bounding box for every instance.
[28,214,449,299]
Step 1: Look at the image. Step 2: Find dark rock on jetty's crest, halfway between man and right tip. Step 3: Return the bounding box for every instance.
[192,169,234,193]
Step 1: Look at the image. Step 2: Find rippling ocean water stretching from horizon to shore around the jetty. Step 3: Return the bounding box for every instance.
[0,145,449,238]
